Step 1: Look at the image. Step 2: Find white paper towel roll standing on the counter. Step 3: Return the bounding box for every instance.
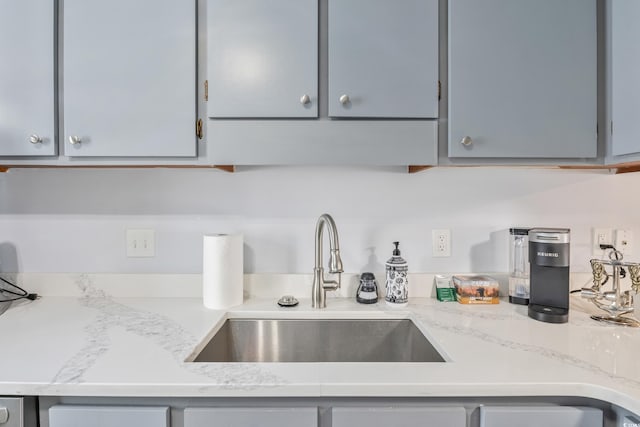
[202,234,244,310]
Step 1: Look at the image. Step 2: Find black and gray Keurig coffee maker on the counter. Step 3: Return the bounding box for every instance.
[529,228,570,323]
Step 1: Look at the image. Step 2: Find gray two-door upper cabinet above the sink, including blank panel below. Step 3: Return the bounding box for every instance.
[208,0,438,165]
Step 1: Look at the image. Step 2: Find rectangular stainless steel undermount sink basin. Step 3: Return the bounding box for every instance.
[192,319,445,362]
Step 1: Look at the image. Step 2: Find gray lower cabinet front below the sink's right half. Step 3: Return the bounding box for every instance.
[331,407,467,427]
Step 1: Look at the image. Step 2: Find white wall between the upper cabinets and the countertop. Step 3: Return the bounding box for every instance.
[0,167,640,273]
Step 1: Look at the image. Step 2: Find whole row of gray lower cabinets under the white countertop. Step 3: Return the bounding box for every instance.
[36,396,620,427]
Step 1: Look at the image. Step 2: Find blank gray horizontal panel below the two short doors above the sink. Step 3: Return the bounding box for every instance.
[208,120,438,166]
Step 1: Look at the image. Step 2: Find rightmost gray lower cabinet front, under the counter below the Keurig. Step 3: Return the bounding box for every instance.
[480,406,603,427]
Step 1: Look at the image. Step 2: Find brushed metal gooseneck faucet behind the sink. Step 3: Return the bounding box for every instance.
[311,214,343,308]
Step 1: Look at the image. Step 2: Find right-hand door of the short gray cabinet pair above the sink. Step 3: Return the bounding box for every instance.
[328,0,438,118]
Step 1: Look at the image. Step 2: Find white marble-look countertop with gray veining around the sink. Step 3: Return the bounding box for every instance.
[0,281,640,413]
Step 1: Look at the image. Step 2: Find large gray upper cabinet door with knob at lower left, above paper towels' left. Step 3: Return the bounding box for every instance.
[62,0,196,157]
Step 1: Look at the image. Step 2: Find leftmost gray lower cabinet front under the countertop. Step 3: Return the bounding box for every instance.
[49,405,169,427]
